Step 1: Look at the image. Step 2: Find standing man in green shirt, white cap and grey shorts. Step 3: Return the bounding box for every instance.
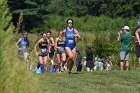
[118,26,132,71]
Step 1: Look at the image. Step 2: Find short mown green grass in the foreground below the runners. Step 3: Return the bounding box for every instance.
[37,71,140,93]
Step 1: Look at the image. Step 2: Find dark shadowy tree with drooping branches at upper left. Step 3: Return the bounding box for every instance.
[8,0,50,30]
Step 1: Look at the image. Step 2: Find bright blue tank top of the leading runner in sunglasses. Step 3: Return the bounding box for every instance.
[65,28,76,48]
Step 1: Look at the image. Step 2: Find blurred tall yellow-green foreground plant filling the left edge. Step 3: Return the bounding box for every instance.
[0,0,42,93]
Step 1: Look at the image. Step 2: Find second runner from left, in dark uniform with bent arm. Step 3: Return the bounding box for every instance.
[35,33,49,72]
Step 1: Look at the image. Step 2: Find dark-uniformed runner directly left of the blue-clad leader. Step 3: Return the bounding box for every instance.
[55,32,66,72]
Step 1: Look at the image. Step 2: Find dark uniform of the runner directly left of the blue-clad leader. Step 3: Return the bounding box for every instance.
[57,39,65,54]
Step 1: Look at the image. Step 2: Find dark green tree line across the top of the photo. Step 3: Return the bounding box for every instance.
[8,0,140,29]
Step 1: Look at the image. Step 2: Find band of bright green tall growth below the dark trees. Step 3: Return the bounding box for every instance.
[31,15,140,32]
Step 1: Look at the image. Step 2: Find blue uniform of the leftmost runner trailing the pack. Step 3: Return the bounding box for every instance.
[18,37,29,54]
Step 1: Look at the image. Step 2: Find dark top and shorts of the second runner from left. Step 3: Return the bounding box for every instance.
[39,41,48,57]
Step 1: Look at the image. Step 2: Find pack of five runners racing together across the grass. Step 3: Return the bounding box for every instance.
[16,19,80,74]
